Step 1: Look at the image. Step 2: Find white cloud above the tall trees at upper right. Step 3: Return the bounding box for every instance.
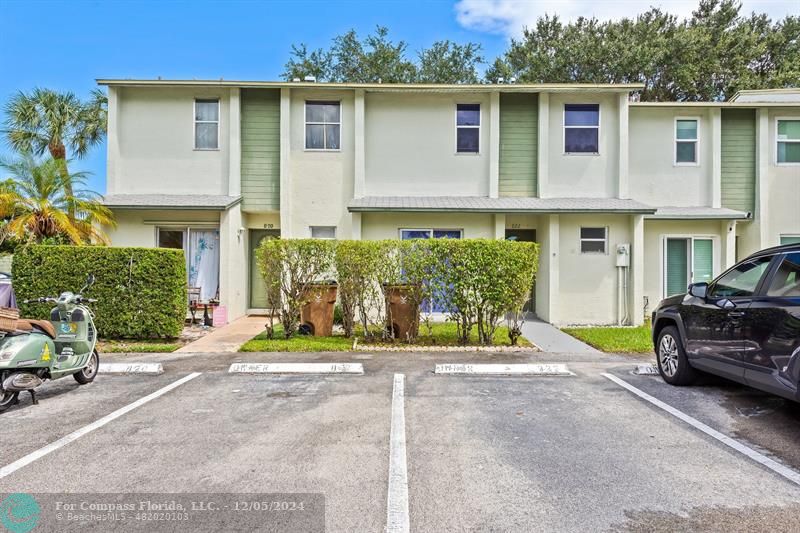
[455,0,798,37]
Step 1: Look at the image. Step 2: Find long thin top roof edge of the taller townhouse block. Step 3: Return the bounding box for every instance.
[96,78,644,93]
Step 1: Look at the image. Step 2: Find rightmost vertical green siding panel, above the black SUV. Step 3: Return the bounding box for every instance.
[721,109,756,212]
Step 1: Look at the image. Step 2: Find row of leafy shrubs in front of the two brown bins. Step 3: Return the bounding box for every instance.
[258,239,538,344]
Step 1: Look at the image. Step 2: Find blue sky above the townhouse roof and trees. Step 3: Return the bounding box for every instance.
[0,0,796,193]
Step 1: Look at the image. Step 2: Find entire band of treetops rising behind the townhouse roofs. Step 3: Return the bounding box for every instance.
[283,0,800,101]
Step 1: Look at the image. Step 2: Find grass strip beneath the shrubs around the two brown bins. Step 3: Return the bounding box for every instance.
[239,322,531,352]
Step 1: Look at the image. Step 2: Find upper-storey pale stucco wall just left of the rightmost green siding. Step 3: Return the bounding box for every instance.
[628,106,714,207]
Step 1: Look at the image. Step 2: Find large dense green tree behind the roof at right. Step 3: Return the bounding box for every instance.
[494,0,800,100]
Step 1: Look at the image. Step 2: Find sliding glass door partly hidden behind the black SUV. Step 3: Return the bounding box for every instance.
[664,237,714,296]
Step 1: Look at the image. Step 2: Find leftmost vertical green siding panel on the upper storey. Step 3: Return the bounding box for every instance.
[241,89,281,211]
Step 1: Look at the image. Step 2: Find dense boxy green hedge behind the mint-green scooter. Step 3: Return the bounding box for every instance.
[12,246,187,338]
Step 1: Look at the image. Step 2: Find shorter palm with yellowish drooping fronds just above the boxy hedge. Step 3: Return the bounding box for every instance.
[0,154,116,244]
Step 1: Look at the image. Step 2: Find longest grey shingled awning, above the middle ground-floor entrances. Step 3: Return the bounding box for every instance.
[347,196,656,215]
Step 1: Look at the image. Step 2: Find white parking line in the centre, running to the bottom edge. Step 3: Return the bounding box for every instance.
[386,374,410,533]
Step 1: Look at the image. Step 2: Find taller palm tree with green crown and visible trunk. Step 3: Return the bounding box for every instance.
[3,88,108,215]
